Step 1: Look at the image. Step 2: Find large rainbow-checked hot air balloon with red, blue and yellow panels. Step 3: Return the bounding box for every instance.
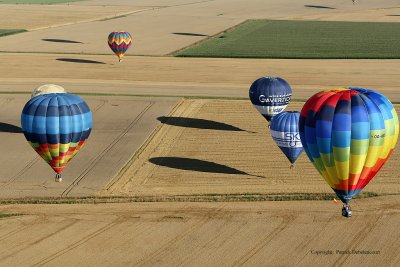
[299,88,399,217]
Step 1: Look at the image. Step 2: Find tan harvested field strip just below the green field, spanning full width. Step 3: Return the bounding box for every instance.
[0,53,400,102]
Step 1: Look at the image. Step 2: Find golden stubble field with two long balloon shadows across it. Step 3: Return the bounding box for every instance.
[102,100,400,196]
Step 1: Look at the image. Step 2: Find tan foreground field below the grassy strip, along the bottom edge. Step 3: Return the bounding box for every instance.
[0,197,400,266]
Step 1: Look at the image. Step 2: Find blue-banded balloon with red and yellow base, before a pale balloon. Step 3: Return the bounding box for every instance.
[21,89,92,182]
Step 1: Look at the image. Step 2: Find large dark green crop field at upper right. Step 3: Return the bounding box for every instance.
[175,20,400,59]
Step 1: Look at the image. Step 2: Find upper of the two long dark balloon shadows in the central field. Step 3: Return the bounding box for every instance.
[157,116,254,133]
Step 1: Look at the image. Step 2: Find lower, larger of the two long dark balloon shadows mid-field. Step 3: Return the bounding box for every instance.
[149,157,265,178]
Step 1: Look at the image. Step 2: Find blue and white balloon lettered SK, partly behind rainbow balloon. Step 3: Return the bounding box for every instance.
[270,111,303,168]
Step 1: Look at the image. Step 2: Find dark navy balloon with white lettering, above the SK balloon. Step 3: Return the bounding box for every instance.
[249,77,292,122]
